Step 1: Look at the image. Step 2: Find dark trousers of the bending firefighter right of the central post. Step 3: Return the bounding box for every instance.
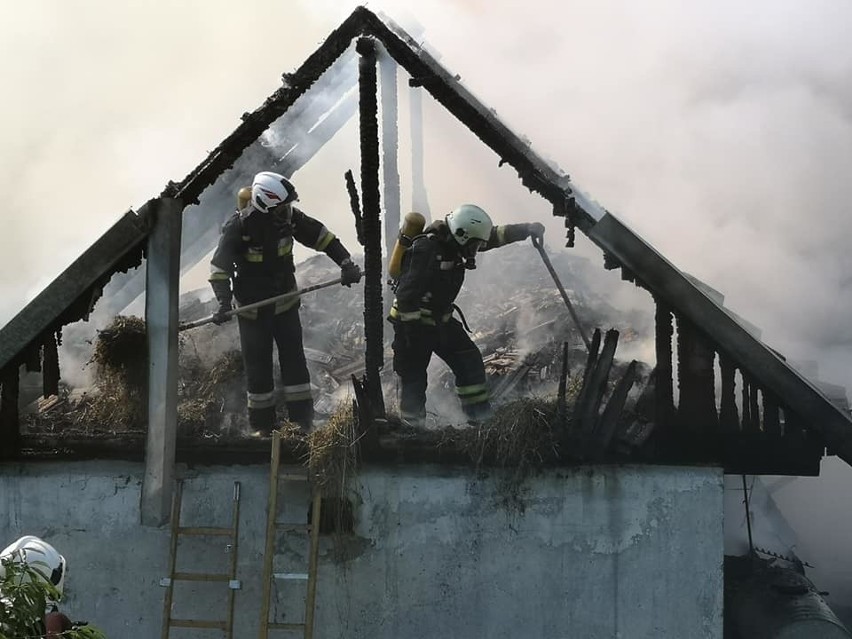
[393,317,491,423]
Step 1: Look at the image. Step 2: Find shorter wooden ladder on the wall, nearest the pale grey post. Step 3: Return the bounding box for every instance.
[160,480,241,639]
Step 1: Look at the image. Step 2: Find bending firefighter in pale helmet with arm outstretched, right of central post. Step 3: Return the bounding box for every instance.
[388,204,544,424]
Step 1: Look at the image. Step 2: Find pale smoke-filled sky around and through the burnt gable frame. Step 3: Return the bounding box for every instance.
[5,0,852,602]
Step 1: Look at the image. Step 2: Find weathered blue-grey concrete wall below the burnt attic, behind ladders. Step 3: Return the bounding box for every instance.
[0,462,723,639]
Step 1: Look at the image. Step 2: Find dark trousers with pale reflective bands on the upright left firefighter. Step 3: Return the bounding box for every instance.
[237,306,313,433]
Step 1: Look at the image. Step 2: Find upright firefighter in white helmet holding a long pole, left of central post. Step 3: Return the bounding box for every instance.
[210,171,361,434]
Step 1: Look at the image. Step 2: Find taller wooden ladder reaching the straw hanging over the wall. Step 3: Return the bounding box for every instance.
[259,430,322,639]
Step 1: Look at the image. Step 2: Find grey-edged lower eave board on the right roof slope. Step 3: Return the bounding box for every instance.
[587,214,852,464]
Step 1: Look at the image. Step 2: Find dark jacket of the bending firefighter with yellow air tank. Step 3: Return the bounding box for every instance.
[390,220,529,326]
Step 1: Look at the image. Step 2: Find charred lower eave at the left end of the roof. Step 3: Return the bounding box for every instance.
[0,210,148,370]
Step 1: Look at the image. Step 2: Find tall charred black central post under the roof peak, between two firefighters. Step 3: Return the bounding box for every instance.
[356,38,385,415]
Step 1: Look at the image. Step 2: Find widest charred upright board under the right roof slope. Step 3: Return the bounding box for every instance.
[677,316,719,432]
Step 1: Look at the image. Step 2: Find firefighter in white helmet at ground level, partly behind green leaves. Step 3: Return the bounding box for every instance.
[0,535,72,637]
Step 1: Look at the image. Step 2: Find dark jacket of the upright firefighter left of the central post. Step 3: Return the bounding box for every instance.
[210,206,349,313]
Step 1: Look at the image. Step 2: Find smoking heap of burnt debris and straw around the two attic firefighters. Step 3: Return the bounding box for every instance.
[24,245,652,463]
